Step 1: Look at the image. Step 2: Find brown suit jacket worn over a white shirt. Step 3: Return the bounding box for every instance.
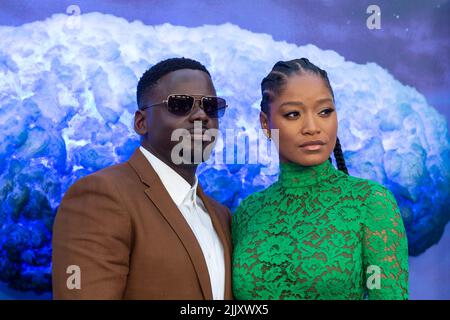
[52,149,232,300]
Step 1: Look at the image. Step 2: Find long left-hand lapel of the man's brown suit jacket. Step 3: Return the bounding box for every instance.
[129,149,213,300]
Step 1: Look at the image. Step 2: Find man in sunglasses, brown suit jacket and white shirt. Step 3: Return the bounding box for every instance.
[52,58,232,299]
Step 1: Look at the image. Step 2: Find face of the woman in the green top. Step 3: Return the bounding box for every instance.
[260,73,338,166]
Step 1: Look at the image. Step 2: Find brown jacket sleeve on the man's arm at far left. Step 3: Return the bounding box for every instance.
[52,175,131,299]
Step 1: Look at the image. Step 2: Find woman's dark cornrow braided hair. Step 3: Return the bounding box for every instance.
[261,58,348,174]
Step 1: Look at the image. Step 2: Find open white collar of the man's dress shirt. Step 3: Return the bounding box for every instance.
[139,146,198,206]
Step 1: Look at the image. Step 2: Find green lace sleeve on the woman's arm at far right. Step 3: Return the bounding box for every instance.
[363,184,408,299]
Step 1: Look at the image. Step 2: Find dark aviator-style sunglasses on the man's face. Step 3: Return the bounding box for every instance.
[141,94,227,118]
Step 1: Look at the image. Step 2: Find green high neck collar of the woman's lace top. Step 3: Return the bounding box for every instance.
[278,160,336,188]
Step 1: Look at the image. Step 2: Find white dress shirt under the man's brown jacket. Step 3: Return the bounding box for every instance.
[139,146,225,300]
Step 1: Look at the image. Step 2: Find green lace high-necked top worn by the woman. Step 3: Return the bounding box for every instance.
[232,161,408,299]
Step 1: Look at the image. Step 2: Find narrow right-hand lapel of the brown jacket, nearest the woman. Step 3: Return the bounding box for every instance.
[197,185,232,299]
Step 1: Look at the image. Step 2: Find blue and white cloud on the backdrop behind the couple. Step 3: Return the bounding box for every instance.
[0,13,450,292]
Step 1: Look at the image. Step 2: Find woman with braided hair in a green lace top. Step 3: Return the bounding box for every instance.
[232,58,408,299]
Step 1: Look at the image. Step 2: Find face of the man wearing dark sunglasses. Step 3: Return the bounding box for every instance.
[135,69,218,163]
